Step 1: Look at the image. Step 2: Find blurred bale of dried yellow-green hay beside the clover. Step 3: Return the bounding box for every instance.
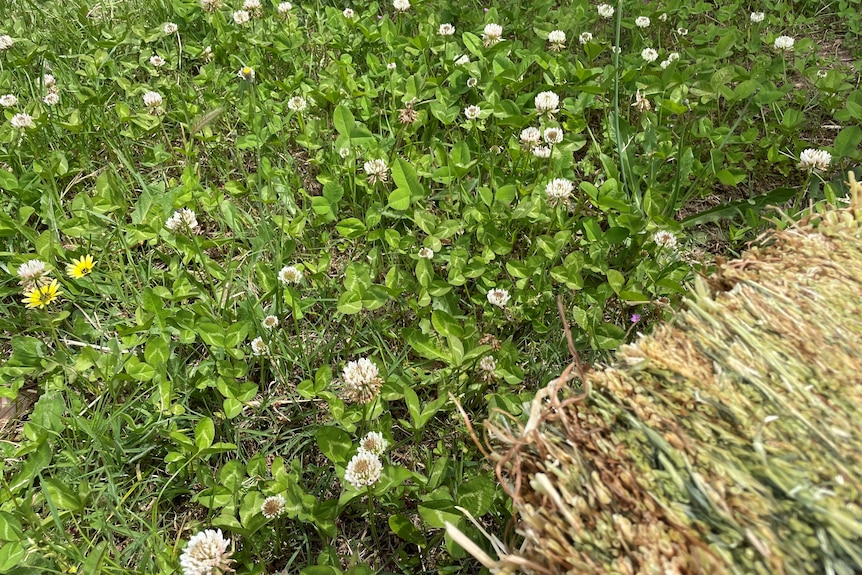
[449,176,862,575]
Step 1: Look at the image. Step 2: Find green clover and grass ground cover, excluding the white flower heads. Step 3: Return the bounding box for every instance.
[0,0,862,575]
